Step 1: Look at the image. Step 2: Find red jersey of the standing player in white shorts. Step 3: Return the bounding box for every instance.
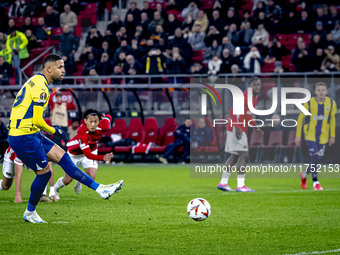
[227,90,257,132]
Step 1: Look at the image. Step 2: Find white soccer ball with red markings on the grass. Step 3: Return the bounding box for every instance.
[187,198,211,221]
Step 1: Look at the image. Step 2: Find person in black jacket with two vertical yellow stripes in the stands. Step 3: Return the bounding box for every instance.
[141,40,165,83]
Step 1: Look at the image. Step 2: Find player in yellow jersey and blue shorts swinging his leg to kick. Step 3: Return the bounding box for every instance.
[8,54,123,223]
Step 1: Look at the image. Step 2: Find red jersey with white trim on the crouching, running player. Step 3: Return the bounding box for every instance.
[67,114,112,160]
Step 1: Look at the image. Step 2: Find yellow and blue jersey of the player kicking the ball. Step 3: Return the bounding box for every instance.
[9,74,55,136]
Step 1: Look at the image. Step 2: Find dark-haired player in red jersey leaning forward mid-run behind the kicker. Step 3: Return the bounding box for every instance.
[54,109,113,199]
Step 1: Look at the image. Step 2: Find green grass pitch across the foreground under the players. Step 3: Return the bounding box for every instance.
[0,164,340,255]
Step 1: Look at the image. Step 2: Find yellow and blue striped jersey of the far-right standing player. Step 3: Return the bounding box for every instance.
[296,97,337,144]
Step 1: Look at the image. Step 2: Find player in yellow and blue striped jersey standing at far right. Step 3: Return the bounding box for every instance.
[295,82,337,190]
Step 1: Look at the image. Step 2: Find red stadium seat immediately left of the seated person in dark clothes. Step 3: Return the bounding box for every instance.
[150,118,178,153]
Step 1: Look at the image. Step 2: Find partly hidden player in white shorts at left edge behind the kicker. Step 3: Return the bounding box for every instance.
[0,147,23,203]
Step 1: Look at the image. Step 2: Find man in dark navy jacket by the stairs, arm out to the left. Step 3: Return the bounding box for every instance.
[50,25,79,61]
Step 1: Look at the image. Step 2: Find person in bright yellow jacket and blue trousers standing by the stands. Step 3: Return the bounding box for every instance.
[6,27,29,82]
